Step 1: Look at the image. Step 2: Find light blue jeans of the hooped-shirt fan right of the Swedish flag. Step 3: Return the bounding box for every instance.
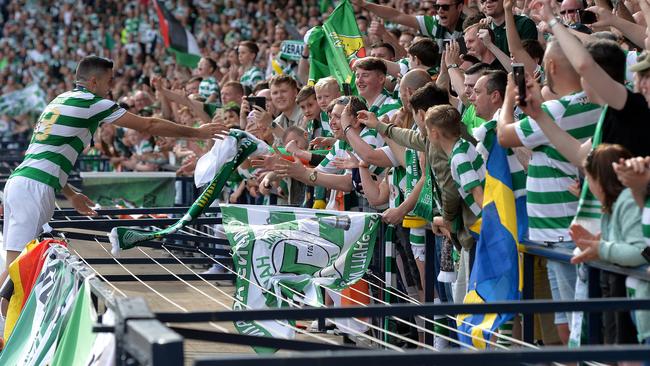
[546,241,578,324]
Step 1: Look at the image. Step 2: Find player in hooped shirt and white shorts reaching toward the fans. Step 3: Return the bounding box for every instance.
[0,56,226,283]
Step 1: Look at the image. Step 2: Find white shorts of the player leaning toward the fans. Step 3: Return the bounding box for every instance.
[2,177,55,252]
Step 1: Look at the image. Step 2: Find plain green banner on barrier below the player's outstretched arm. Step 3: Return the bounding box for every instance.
[81,172,176,207]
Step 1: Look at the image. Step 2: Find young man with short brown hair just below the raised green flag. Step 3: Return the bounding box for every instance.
[354,57,400,117]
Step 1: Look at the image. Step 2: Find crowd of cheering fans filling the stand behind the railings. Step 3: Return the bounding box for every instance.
[0,0,650,356]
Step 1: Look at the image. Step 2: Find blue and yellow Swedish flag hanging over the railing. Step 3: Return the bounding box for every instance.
[458,136,528,349]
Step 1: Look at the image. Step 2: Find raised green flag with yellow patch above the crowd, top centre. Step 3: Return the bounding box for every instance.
[307,0,366,91]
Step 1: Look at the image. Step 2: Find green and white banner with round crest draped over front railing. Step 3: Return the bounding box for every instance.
[221,205,380,352]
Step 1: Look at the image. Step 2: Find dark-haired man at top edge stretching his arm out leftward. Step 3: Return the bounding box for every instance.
[353,0,463,51]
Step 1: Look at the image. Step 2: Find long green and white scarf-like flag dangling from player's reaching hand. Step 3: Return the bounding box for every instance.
[108,129,269,256]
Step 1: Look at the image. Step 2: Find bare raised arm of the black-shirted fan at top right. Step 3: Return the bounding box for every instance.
[533,0,627,110]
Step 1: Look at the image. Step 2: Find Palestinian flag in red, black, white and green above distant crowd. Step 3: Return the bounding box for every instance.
[153,1,201,68]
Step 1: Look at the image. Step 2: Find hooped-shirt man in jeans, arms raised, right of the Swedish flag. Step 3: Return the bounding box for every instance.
[497,41,602,344]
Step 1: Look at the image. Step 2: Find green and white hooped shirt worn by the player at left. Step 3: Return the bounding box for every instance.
[11,87,126,191]
